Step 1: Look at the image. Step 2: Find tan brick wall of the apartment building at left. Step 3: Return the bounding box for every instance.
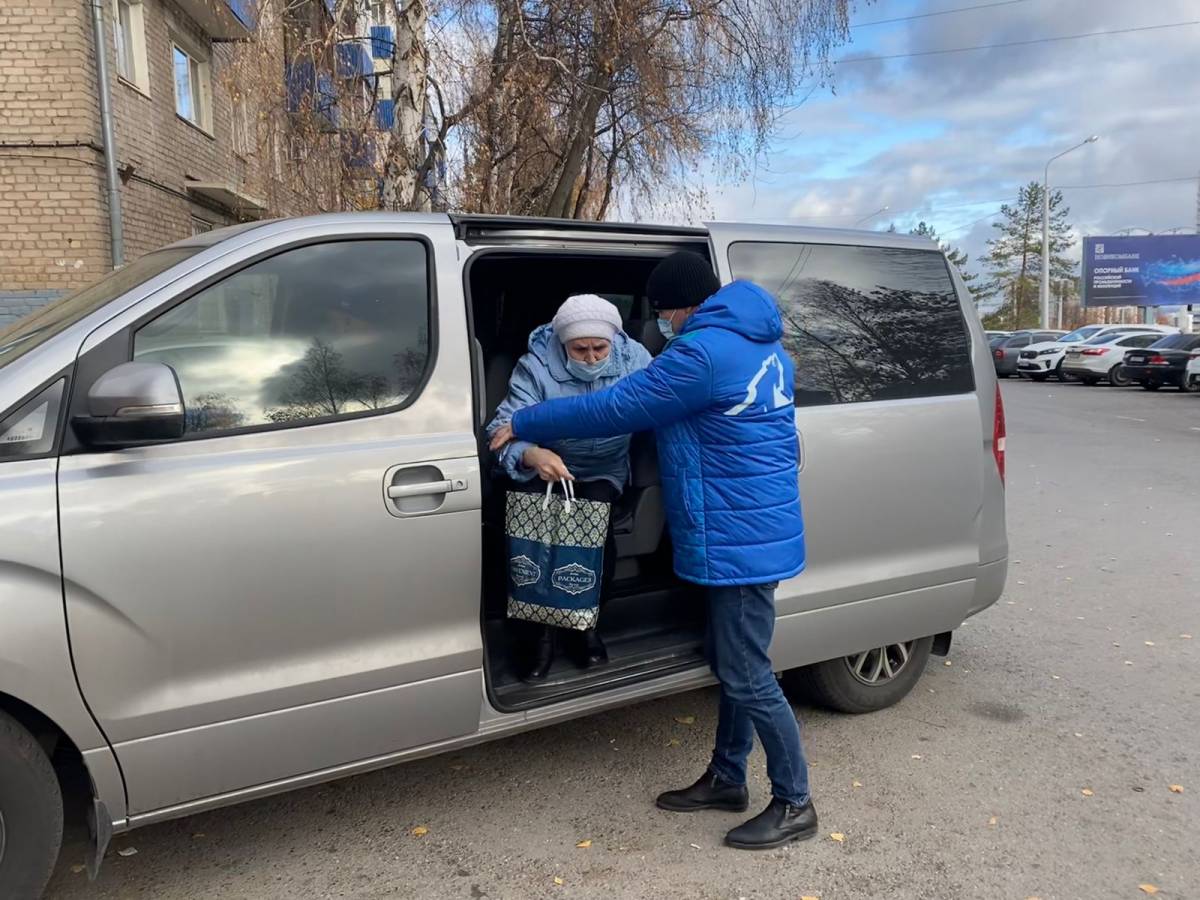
[0,0,304,307]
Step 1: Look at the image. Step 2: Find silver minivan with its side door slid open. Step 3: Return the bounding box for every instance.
[0,214,1008,896]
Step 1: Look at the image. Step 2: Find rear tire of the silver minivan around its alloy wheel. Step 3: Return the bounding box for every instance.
[784,637,934,714]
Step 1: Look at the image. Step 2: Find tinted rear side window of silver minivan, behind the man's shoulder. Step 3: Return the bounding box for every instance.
[730,241,974,406]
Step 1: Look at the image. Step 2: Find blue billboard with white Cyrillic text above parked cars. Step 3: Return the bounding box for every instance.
[1084,234,1200,306]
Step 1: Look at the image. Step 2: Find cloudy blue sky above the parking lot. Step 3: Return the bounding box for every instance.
[709,0,1200,280]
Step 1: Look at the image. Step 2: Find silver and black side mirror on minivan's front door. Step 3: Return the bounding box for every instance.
[71,362,184,449]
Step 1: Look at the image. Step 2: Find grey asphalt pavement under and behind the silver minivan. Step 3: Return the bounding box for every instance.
[42,380,1200,900]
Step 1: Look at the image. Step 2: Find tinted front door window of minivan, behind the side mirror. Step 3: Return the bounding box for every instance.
[133,240,430,433]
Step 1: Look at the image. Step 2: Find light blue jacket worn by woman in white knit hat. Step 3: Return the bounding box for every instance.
[487,325,650,491]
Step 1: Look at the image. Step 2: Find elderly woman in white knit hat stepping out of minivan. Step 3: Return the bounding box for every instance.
[487,294,650,680]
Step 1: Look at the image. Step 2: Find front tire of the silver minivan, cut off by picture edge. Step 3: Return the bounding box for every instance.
[0,712,62,898]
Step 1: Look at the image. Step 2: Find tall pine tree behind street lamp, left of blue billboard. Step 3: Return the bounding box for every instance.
[978,181,1075,330]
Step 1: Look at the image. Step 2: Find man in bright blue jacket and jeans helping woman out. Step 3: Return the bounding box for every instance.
[493,252,817,850]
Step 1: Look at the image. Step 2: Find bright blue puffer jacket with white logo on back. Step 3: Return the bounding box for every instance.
[512,281,804,584]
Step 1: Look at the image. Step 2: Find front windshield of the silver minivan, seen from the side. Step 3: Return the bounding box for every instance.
[0,246,204,367]
